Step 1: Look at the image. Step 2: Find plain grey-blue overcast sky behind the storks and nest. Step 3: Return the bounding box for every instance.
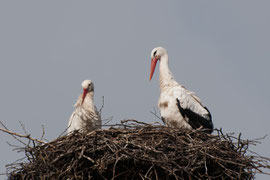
[0,0,270,179]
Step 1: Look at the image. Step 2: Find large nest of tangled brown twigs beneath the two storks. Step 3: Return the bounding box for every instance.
[5,120,270,180]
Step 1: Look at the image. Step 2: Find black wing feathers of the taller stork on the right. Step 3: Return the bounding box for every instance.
[176,99,213,134]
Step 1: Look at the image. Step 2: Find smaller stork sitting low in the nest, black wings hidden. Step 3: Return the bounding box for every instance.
[67,80,101,134]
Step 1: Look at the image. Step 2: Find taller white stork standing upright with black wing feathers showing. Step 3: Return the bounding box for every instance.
[150,47,213,133]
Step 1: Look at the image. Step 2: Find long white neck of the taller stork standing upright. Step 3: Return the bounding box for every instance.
[159,54,178,90]
